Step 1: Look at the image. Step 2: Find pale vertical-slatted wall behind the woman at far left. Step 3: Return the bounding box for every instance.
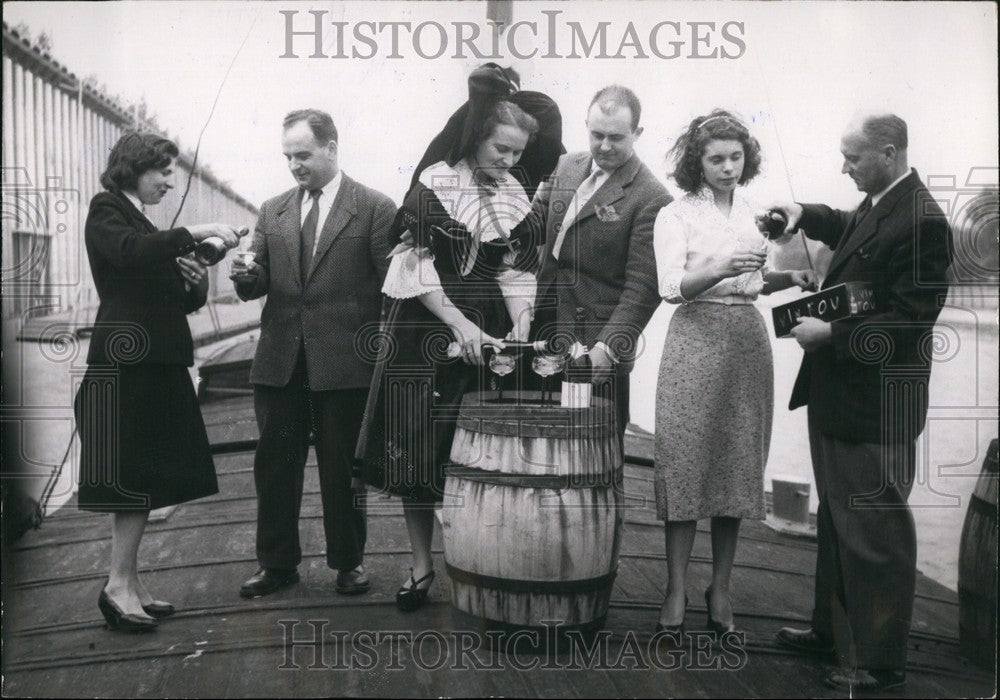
[0,23,257,319]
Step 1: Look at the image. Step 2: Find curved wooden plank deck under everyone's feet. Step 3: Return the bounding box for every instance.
[3,398,996,698]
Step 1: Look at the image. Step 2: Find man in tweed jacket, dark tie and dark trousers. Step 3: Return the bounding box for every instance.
[232,109,396,598]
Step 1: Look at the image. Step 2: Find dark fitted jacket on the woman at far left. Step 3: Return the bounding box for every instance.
[84,192,208,366]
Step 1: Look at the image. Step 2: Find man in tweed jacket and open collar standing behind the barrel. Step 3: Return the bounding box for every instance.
[533,85,671,435]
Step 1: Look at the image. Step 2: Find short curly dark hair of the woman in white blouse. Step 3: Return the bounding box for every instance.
[667,109,761,192]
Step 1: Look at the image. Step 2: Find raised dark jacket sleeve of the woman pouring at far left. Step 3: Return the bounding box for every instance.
[84,193,194,270]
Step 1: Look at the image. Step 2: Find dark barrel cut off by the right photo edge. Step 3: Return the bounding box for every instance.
[958,439,997,669]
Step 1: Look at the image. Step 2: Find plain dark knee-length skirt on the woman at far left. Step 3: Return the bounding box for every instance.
[74,364,219,513]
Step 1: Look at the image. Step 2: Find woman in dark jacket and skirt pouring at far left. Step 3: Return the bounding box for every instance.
[75,133,239,631]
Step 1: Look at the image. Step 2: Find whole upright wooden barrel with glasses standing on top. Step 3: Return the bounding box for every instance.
[441,392,622,629]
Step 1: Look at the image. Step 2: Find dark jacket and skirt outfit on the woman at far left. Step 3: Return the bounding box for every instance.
[74,192,218,512]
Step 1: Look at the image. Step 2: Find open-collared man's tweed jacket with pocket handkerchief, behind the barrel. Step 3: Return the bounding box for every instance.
[533,152,671,365]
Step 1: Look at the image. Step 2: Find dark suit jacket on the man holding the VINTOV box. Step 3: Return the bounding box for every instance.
[789,171,952,443]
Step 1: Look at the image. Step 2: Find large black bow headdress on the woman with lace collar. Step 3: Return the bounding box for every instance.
[410,63,566,199]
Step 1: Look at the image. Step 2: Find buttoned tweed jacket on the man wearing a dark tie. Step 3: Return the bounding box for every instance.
[236,175,396,391]
